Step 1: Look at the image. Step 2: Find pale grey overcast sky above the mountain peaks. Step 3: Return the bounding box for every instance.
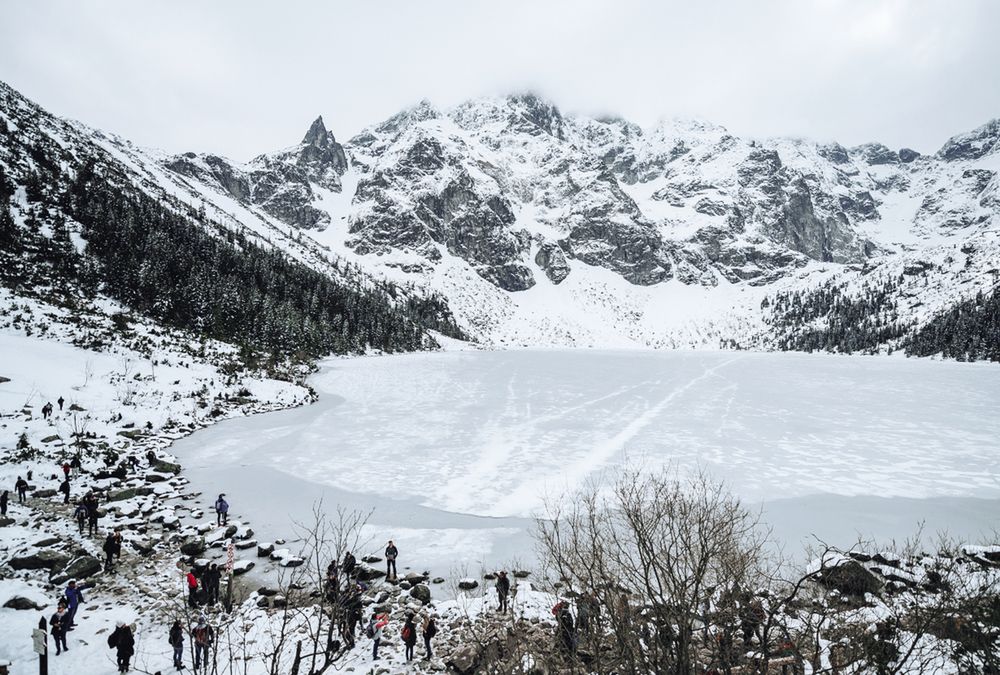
[0,0,1000,160]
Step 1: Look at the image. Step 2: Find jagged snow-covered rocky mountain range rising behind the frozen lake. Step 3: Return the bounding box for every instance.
[1,80,1000,350]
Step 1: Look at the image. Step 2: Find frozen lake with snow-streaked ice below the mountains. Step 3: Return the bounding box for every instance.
[175,350,1000,573]
